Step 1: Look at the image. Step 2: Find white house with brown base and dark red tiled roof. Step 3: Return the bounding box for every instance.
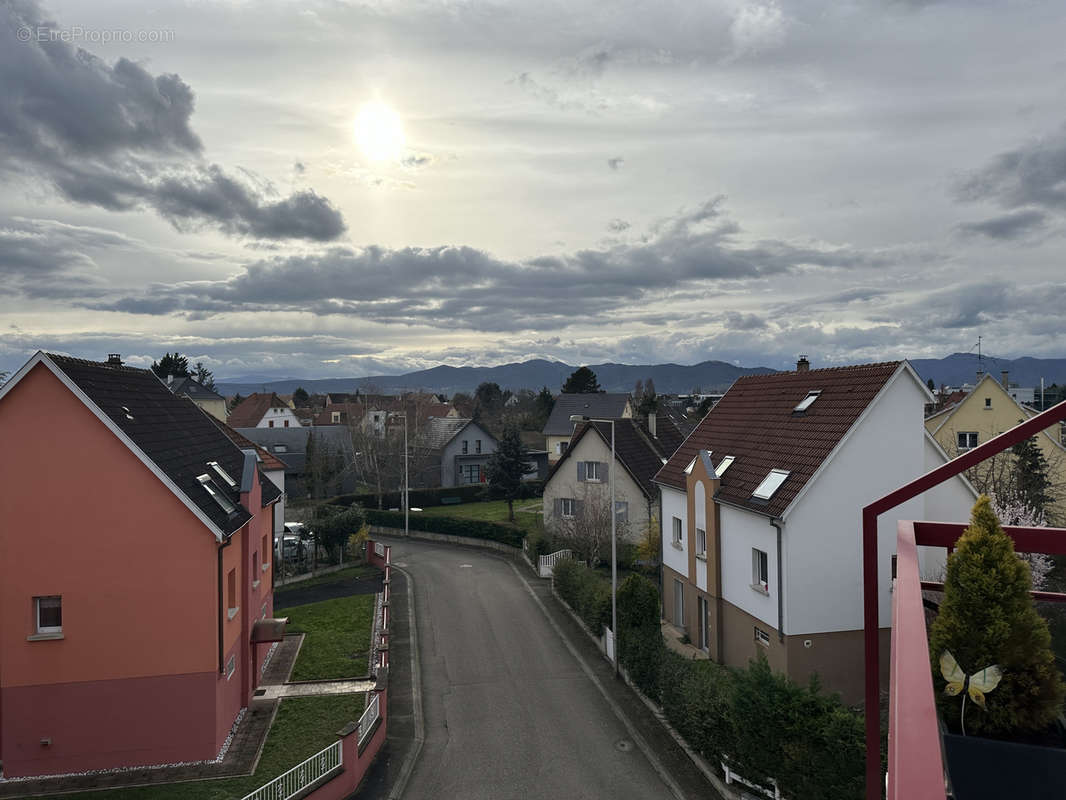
[655,362,974,703]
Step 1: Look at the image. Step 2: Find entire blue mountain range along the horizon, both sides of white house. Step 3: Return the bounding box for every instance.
[217,353,1066,396]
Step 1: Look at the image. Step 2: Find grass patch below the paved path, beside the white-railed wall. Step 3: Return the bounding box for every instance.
[62,695,369,800]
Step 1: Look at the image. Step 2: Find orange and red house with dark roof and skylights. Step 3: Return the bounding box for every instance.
[0,352,284,778]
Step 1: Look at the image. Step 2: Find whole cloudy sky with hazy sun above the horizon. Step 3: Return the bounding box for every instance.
[0,0,1066,378]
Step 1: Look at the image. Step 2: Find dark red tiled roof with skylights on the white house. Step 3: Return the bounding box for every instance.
[656,362,902,516]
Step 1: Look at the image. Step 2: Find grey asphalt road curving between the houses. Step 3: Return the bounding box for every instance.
[392,540,674,800]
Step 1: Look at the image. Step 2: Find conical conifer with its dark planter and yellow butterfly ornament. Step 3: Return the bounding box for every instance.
[930,496,1066,800]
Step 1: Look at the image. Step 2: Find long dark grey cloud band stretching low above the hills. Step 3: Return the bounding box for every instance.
[88,197,908,331]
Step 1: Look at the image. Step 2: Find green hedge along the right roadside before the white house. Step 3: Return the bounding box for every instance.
[554,561,865,800]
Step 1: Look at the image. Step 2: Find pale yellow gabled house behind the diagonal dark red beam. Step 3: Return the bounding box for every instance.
[925,372,1066,524]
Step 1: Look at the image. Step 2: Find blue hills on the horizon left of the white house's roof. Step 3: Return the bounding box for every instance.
[217,358,776,396]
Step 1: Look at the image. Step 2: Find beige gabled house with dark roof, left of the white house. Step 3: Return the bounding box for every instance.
[544,414,681,543]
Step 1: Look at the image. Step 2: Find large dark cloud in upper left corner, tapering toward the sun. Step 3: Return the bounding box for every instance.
[0,0,345,241]
